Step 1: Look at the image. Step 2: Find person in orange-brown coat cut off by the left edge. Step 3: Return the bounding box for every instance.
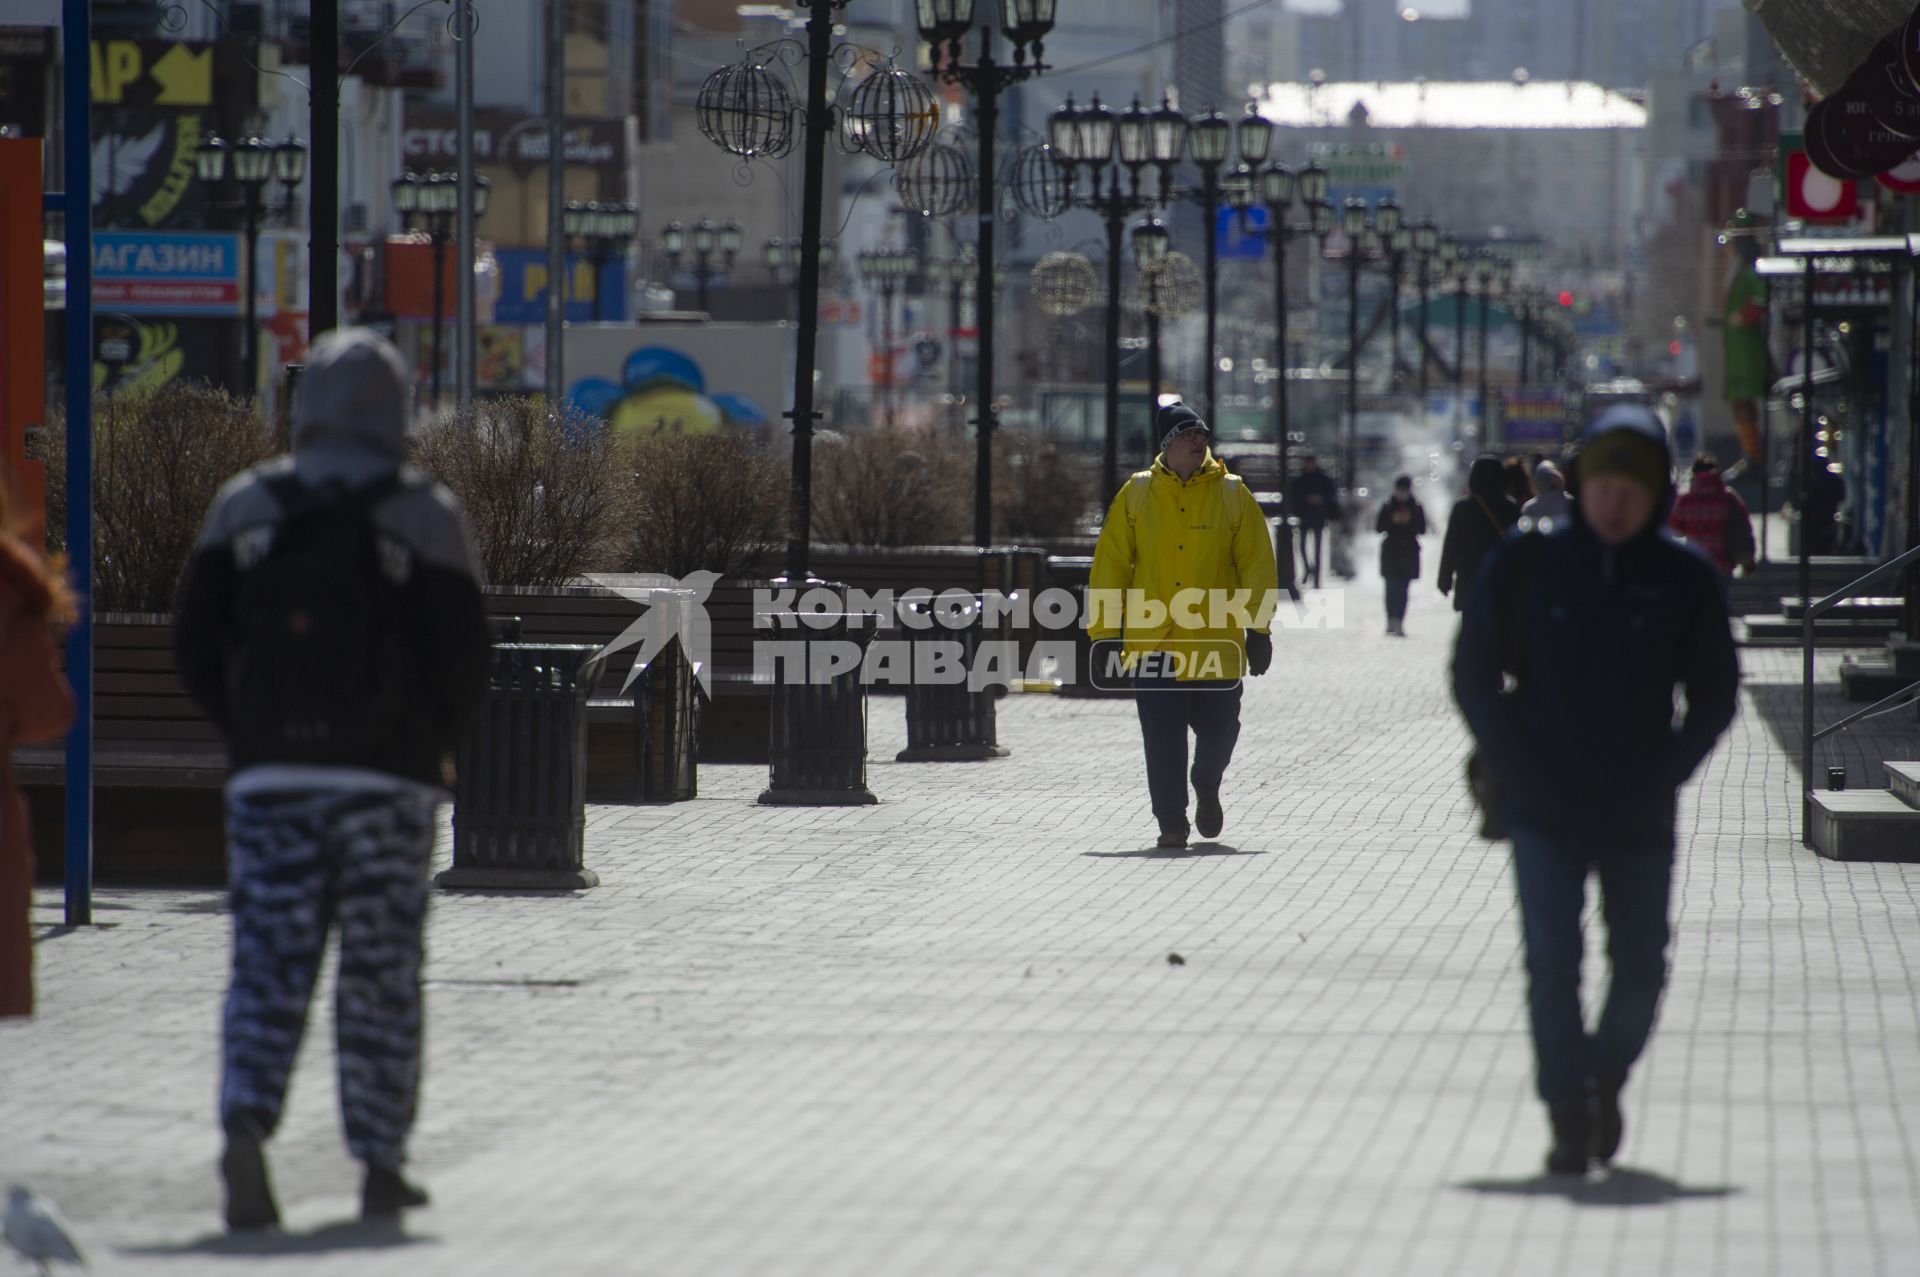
[0,501,73,1020]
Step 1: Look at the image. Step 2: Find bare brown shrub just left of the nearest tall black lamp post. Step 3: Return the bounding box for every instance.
[618,430,789,576]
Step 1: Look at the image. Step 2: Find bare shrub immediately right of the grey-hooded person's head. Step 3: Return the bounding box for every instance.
[415,398,630,586]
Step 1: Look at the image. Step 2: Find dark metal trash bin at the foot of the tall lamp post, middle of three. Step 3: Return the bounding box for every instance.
[756,599,879,807]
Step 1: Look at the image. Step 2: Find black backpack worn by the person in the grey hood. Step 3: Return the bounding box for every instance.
[227,472,411,766]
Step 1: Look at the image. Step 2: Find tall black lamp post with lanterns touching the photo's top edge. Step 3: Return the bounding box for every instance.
[914,0,1054,549]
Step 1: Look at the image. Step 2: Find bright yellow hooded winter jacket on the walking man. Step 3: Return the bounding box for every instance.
[1085,453,1279,680]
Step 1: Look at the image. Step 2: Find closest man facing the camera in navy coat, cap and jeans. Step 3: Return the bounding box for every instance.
[1453,405,1740,1173]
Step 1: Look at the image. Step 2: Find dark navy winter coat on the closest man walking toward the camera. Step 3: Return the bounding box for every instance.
[1453,412,1740,855]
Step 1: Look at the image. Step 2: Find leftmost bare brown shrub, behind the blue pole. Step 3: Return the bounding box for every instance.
[42,382,275,613]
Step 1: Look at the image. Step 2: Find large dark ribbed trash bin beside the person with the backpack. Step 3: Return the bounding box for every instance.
[434,643,605,891]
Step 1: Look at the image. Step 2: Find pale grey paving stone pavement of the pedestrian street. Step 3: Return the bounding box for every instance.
[0,572,1920,1277]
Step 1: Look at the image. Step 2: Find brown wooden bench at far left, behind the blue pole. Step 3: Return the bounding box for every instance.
[13,613,227,881]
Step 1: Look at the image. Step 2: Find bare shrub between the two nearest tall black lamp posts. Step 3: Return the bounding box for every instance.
[814,426,973,545]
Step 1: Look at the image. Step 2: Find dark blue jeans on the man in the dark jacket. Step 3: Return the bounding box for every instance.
[1513,830,1674,1104]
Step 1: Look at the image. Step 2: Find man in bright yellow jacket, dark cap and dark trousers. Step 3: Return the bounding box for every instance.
[1087,403,1279,847]
